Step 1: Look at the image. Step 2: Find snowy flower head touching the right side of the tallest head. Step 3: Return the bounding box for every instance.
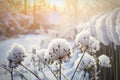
[89,36,100,53]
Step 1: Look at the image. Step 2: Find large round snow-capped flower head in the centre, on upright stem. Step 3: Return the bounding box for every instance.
[48,39,72,60]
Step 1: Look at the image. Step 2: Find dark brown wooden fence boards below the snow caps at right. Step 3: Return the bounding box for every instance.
[97,44,120,80]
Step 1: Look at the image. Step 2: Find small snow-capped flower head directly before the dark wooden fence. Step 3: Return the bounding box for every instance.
[98,54,111,67]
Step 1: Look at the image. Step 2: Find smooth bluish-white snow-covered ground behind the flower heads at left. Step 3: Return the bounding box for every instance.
[0,34,53,63]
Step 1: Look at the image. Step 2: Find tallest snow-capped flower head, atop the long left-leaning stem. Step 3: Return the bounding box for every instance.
[75,30,90,51]
